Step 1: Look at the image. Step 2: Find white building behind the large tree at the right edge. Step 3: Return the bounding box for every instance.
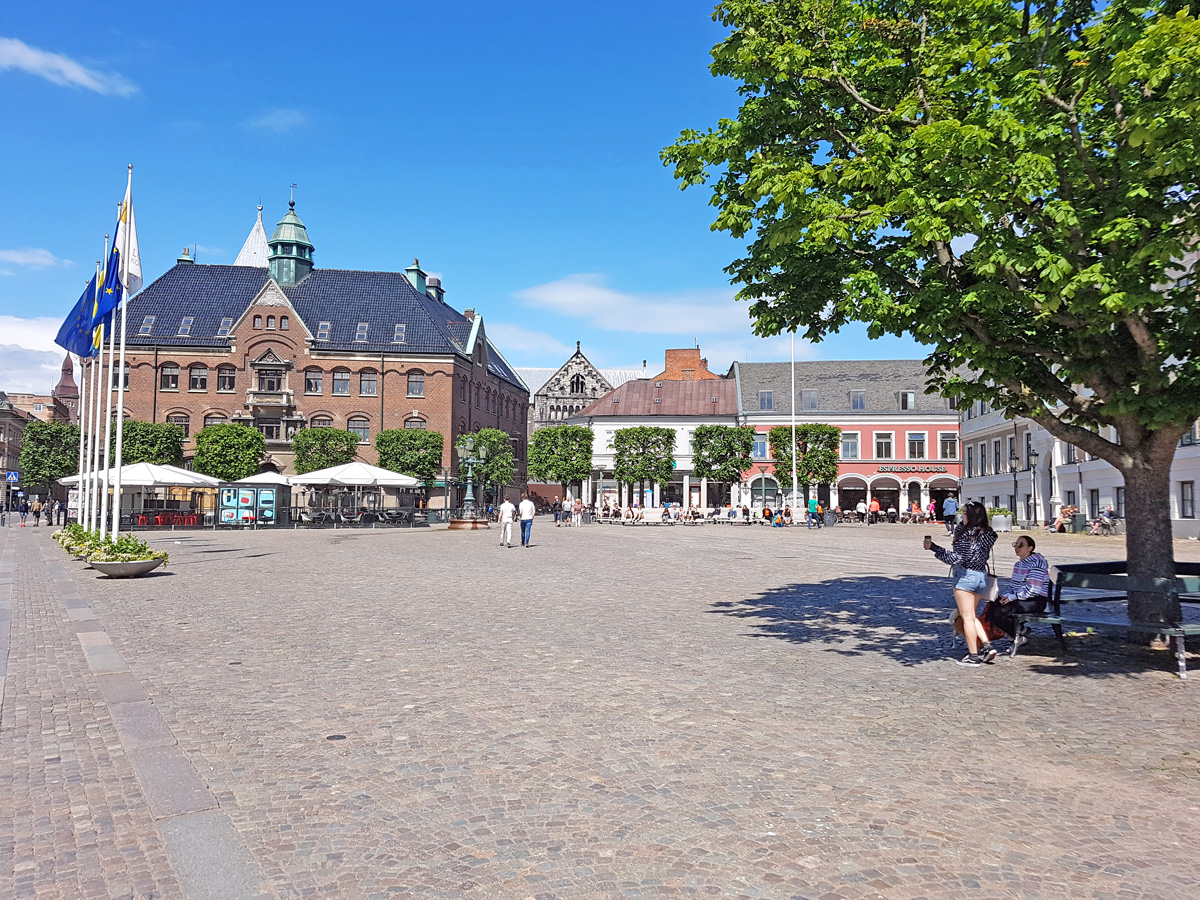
[961,402,1200,538]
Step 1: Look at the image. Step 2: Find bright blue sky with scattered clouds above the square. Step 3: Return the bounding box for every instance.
[0,0,923,390]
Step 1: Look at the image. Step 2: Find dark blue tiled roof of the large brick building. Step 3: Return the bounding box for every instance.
[127,264,521,386]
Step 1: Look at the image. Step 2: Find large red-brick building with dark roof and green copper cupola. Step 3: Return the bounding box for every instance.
[108,202,529,494]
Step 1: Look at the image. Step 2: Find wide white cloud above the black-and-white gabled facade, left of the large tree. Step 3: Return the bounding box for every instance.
[516,274,750,335]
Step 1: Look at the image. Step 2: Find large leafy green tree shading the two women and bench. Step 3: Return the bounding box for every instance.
[664,0,1200,622]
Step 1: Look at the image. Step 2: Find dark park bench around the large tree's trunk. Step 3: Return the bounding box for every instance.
[1009,560,1200,678]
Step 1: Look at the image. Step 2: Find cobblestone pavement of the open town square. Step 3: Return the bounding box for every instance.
[0,518,1200,900]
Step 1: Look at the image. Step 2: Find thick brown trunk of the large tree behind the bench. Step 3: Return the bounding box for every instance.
[1121,440,1182,623]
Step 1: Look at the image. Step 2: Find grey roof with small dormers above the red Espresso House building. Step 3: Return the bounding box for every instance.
[731,359,950,416]
